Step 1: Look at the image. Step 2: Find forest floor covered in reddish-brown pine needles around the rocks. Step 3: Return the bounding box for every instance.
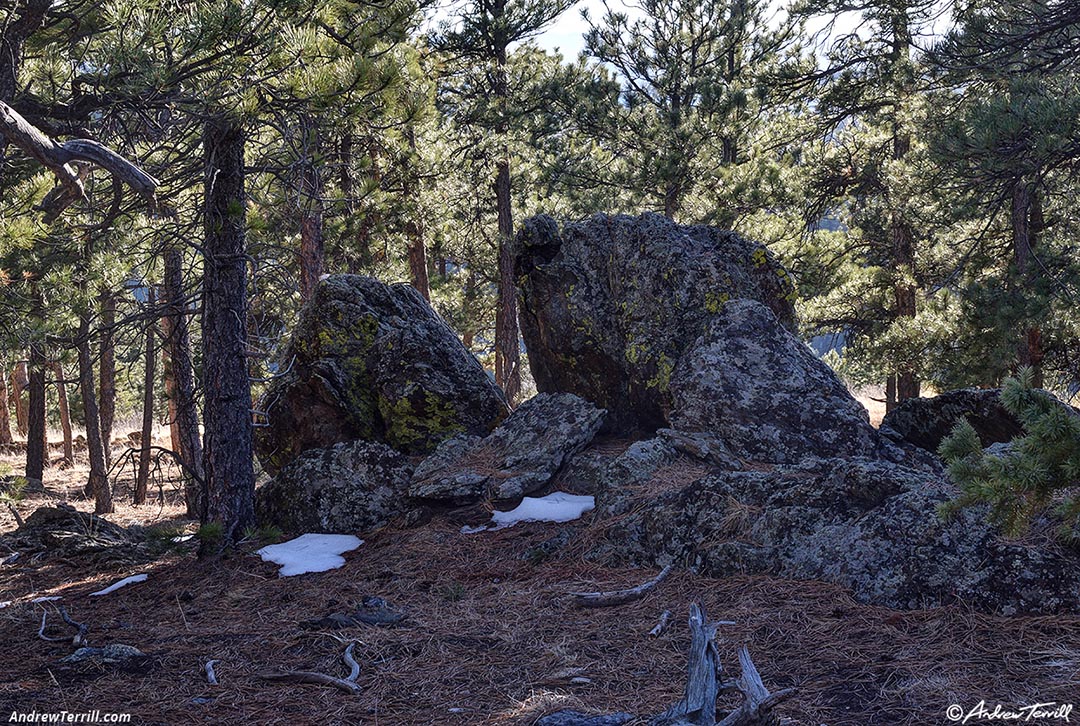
[0,423,1080,726]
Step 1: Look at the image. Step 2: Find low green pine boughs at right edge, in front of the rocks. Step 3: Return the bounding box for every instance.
[939,368,1080,538]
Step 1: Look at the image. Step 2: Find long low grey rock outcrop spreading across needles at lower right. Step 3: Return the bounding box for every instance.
[596,457,1080,615]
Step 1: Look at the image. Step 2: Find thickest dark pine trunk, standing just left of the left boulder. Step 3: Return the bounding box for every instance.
[200,118,255,556]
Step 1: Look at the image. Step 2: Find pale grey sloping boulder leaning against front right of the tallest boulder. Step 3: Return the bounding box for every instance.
[671,299,879,463]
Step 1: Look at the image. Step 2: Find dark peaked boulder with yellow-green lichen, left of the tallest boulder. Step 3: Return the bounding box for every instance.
[256,274,508,474]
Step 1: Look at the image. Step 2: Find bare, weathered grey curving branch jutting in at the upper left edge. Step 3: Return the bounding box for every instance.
[0,100,158,223]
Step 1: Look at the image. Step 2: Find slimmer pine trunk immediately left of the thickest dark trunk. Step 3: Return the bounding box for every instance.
[164,246,203,519]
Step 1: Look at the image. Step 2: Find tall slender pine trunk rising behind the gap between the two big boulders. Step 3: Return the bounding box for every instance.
[491,0,522,405]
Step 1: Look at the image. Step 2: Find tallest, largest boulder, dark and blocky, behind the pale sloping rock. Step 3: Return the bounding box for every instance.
[515,214,795,432]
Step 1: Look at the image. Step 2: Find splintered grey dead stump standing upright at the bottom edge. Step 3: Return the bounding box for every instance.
[649,604,795,726]
